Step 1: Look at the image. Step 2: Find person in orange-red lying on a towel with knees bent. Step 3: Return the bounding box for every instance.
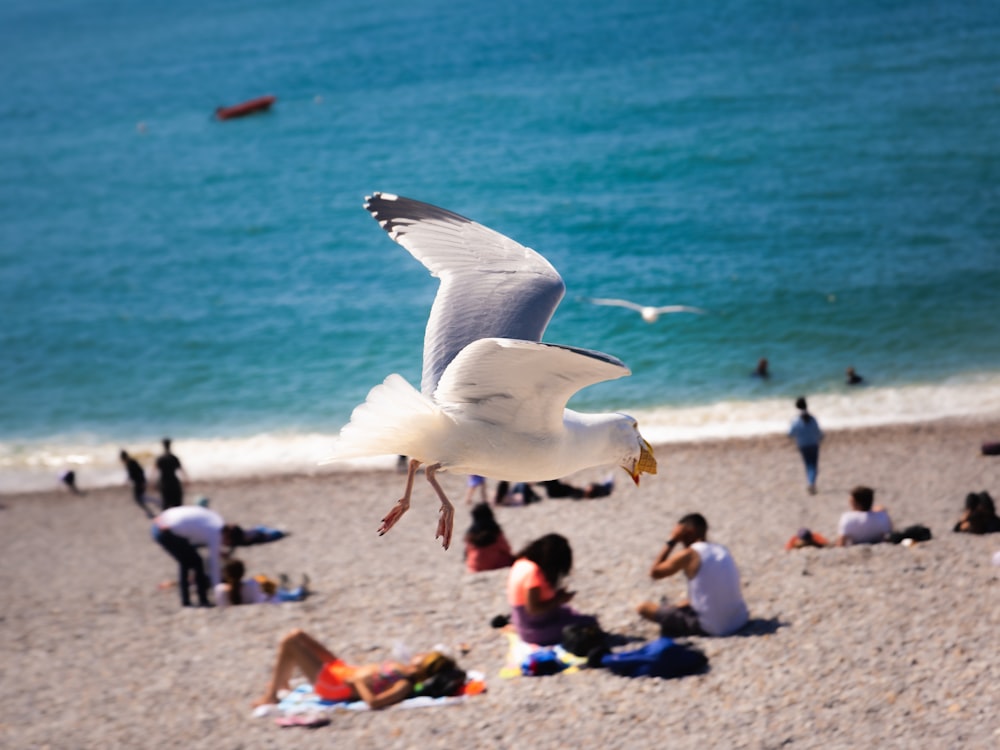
[253,630,457,708]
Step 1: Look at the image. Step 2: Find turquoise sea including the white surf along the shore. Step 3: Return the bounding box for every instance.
[0,0,1000,492]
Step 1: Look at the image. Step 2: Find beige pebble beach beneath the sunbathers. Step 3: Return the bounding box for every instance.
[0,417,1000,750]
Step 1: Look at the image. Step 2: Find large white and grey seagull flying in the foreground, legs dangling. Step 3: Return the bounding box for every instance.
[330,193,656,549]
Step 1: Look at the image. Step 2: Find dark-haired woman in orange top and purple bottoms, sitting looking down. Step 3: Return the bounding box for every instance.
[507,534,600,646]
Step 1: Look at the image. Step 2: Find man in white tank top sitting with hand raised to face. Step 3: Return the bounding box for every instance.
[637,513,750,637]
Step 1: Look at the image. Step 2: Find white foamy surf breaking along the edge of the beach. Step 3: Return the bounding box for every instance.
[7,374,1000,499]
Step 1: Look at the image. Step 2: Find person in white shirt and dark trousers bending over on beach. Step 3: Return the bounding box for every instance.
[152,505,244,607]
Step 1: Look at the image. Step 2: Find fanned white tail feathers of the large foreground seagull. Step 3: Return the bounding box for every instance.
[323,373,447,463]
